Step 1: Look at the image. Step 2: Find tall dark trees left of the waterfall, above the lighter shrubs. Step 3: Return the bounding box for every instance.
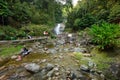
[0,0,62,27]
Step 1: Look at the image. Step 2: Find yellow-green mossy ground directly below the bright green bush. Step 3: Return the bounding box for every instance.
[91,48,115,71]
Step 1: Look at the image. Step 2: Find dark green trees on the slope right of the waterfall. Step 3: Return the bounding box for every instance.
[67,0,120,30]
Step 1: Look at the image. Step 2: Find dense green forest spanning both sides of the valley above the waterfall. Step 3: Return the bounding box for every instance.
[0,0,120,42]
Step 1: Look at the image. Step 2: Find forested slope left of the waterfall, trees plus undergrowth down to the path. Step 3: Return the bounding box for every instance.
[0,0,69,40]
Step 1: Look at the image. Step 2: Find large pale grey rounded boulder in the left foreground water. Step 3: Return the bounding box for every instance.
[24,63,40,73]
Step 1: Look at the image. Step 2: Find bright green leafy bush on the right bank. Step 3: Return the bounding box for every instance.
[90,22,120,49]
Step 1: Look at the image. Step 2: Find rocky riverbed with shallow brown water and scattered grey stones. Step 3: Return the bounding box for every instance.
[0,34,119,80]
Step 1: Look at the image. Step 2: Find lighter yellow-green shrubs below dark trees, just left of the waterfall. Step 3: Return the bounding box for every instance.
[21,24,50,36]
